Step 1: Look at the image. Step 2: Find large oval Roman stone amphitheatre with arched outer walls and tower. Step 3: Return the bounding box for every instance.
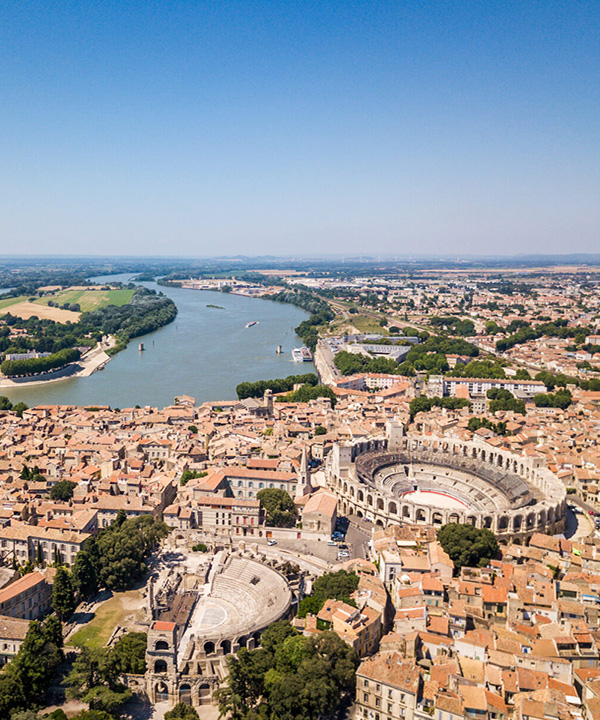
[326,422,566,543]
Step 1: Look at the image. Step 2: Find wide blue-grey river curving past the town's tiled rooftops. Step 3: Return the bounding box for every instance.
[0,275,314,408]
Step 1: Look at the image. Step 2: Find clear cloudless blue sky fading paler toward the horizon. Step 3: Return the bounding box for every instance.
[0,0,600,255]
